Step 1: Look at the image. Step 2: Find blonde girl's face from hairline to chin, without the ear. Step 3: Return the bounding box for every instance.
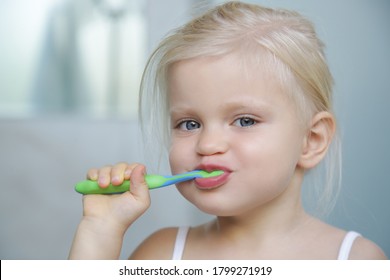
[168,55,305,216]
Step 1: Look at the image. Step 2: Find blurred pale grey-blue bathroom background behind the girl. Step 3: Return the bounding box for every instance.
[0,0,390,259]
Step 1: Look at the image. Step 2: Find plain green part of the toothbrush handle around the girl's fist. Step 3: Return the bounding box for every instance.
[75,175,164,194]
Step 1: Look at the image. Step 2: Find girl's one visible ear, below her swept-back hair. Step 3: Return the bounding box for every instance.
[298,111,336,169]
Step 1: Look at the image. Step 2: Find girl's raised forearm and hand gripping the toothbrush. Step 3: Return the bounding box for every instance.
[69,163,150,259]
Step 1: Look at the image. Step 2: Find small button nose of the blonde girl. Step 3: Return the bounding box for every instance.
[197,129,229,156]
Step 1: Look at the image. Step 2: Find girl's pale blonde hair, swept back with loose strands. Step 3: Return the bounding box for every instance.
[140,1,341,215]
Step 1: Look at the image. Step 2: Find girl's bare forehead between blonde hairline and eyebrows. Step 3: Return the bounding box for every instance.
[168,56,294,108]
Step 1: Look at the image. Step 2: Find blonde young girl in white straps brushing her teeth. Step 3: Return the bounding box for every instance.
[70,2,385,259]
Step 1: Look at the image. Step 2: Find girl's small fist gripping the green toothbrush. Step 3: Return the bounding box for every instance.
[83,163,150,233]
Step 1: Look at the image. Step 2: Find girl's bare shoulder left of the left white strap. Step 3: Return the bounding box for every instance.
[129,227,178,260]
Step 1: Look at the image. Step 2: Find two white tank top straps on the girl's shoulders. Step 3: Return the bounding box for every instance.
[172,227,360,260]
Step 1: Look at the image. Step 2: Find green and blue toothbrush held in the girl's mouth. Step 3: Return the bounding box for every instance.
[75,170,223,194]
